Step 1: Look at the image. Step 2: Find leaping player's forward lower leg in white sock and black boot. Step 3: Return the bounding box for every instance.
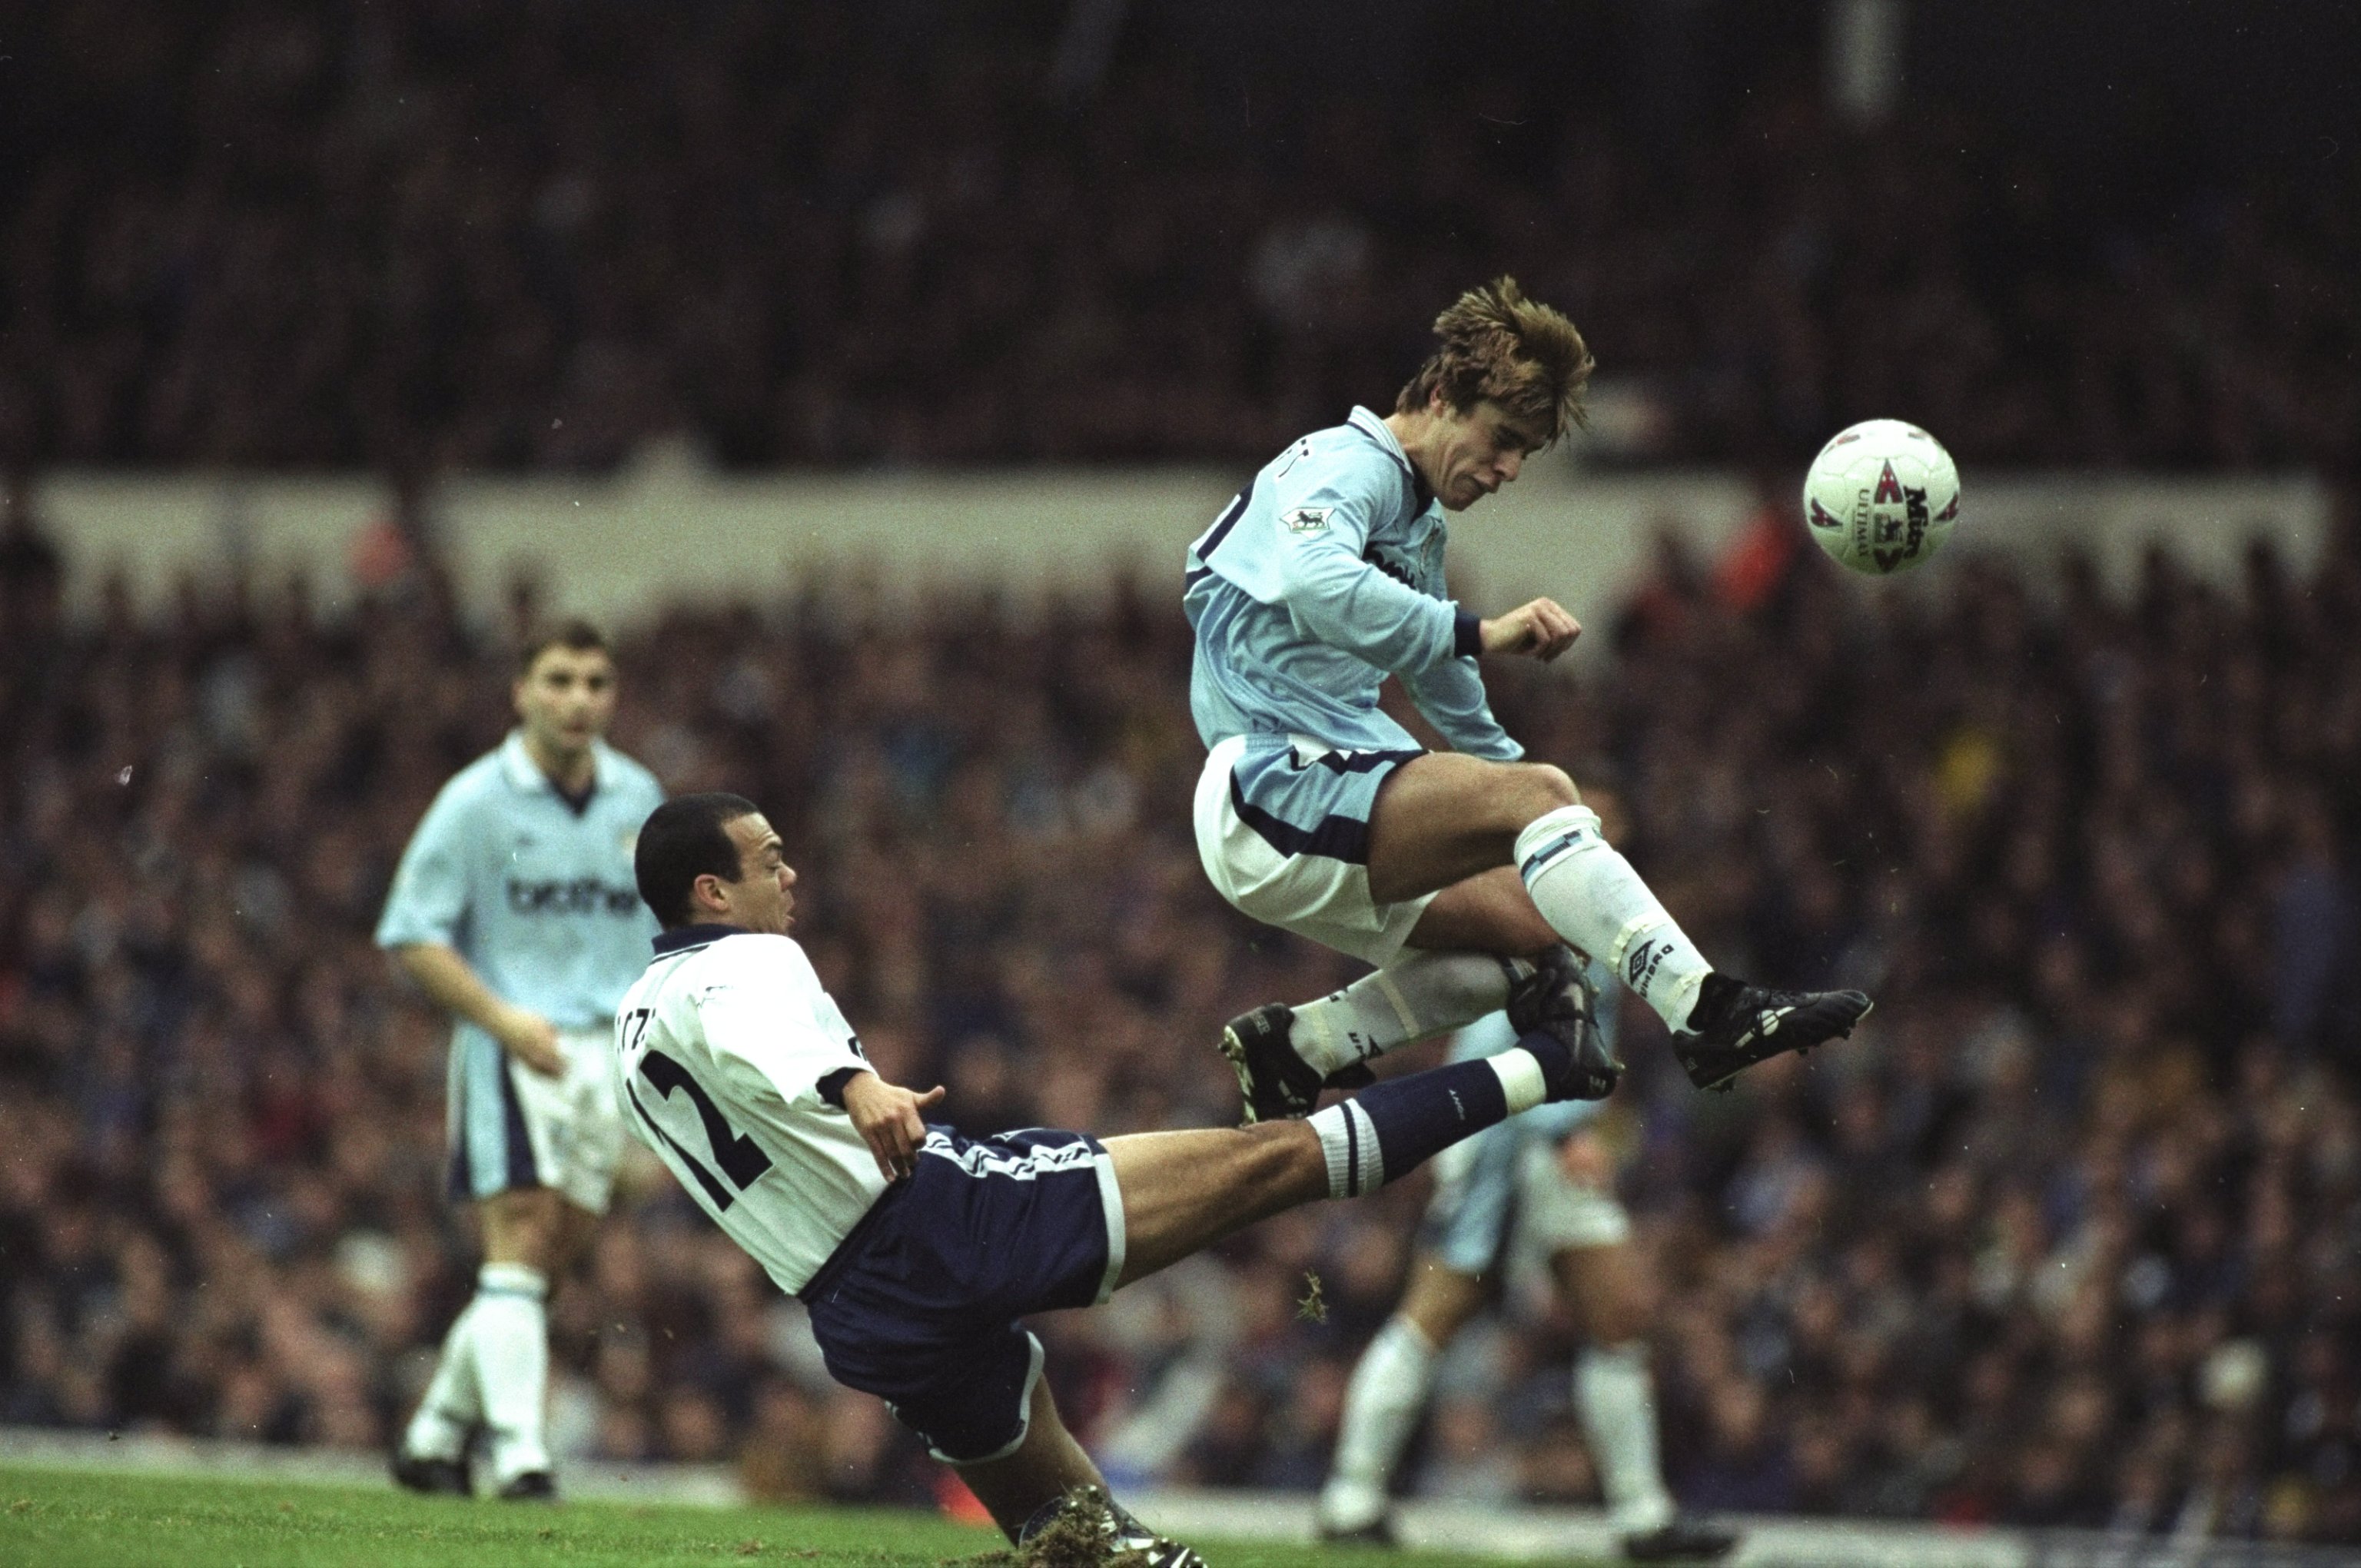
[1516,806,1870,1088]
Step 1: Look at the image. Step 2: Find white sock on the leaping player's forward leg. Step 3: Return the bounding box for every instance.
[1516,806,1714,1030]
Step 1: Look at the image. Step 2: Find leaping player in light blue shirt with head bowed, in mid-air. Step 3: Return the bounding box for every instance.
[1183,279,1870,1121]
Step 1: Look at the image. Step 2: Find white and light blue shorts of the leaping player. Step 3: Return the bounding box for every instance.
[1194,734,1436,963]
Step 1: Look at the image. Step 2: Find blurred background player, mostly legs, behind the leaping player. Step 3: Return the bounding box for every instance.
[1320,791,1738,1561]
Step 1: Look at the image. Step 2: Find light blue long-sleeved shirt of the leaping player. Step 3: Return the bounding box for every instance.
[1183,409,1526,762]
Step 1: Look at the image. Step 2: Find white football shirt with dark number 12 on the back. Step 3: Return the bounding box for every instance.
[614,925,885,1294]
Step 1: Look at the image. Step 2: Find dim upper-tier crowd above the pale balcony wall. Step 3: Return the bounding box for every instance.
[0,0,2361,472]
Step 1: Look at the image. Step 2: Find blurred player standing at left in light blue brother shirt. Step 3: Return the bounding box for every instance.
[378,621,663,1500]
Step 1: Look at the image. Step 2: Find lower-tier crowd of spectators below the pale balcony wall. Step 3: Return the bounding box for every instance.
[0,486,2361,1542]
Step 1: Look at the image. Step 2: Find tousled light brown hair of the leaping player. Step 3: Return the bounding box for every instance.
[1393,276,1596,447]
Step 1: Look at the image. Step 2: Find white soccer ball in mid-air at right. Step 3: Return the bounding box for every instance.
[1804,420,1960,576]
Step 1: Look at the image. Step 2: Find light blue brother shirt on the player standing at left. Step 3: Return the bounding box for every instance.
[378,732,663,1044]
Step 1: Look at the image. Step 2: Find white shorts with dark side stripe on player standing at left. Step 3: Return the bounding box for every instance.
[451,1030,623,1214]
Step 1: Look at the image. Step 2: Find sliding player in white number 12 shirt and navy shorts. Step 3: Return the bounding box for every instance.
[616,796,1615,1568]
